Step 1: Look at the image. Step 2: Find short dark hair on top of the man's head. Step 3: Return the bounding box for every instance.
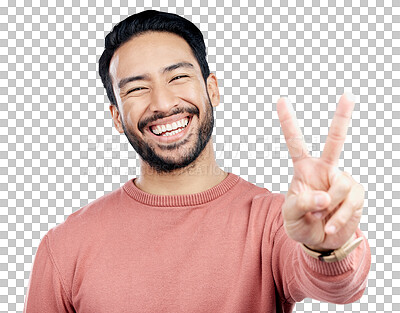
[99,10,210,106]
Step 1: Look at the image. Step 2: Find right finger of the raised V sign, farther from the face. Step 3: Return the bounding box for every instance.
[321,93,355,165]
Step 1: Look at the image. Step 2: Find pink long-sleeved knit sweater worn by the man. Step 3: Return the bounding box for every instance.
[24,173,371,313]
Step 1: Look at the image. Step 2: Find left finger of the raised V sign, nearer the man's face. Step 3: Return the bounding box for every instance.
[276,98,309,164]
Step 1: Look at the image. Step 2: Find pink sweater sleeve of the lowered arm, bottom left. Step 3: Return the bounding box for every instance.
[24,235,75,313]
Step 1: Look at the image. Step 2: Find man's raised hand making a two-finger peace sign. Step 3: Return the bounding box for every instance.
[277,94,364,251]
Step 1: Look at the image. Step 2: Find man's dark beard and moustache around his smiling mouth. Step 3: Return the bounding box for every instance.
[122,97,214,173]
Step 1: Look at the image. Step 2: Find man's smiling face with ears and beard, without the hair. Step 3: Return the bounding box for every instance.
[110,32,219,172]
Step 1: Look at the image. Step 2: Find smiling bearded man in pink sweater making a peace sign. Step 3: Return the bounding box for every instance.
[25,11,371,313]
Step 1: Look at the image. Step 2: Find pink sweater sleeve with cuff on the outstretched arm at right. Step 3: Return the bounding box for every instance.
[272,193,371,304]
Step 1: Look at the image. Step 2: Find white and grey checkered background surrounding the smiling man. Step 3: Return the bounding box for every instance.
[0,0,400,312]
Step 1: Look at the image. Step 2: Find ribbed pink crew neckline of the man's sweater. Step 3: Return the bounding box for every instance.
[123,173,240,207]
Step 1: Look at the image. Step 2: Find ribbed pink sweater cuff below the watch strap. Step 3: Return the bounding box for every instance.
[298,230,365,276]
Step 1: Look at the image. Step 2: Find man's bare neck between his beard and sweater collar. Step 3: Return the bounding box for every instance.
[135,140,228,195]
